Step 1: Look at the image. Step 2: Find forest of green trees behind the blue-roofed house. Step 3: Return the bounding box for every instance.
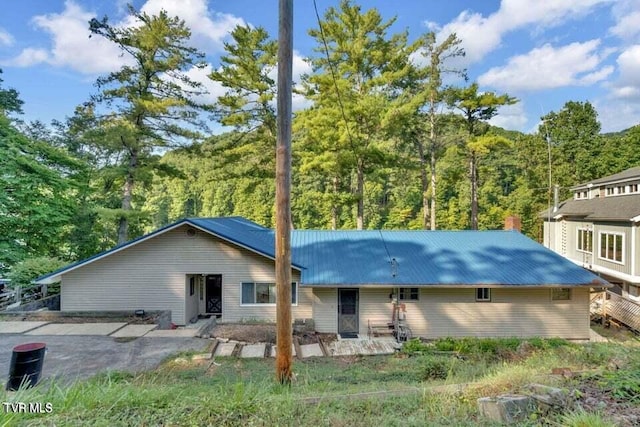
[0,0,640,276]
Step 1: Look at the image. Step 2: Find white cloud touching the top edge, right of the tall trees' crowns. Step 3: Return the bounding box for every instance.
[439,0,611,63]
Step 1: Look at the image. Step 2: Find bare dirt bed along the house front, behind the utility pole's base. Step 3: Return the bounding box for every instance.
[211,323,336,345]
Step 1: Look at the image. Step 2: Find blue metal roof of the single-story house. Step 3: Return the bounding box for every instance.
[37,217,607,286]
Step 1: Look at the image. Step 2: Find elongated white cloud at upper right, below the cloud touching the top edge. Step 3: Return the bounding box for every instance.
[478,39,613,91]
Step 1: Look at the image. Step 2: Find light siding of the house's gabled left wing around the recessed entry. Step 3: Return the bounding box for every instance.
[61,225,312,324]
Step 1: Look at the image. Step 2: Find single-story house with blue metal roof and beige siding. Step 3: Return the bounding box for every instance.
[37,217,608,339]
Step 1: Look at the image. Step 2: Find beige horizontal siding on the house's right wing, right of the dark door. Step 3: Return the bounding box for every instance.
[360,288,589,340]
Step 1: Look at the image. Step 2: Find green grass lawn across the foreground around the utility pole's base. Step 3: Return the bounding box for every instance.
[0,340,640,426]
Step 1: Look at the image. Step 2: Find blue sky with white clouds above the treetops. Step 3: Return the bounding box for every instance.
[0,0,640,133]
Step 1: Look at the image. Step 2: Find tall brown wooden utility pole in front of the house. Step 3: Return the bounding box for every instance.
[276,0,293,385]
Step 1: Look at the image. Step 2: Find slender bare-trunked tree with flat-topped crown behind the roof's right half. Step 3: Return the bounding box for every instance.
[447,83,517,230]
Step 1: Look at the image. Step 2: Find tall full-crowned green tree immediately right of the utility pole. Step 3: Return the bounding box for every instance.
[296,0,412,229]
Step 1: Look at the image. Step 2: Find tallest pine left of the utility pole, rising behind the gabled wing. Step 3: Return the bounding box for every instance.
[86,6,205,243]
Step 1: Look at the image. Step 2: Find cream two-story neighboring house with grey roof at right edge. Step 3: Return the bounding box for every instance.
[542,167,640,301]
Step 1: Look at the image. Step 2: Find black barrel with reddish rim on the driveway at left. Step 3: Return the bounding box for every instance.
[7,342,47,390]
